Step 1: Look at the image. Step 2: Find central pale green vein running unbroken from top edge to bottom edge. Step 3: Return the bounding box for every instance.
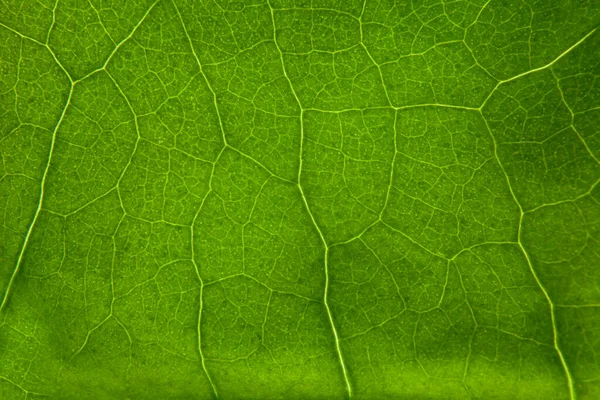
[267,2,352,398]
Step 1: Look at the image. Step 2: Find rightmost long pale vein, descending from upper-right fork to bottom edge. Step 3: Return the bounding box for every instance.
[481,113,576,400]
